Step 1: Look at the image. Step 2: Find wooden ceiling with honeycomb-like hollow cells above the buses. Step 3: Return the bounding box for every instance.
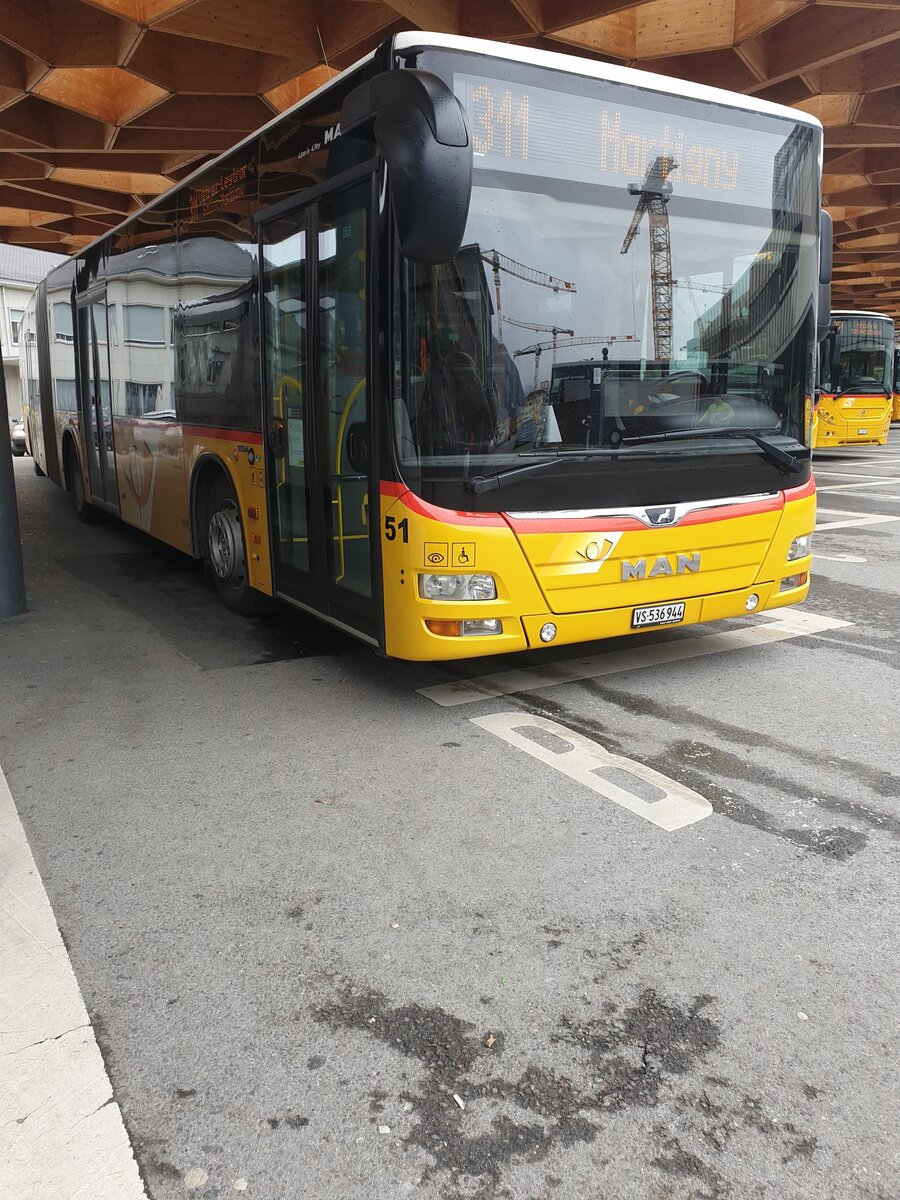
[0,0,900,318]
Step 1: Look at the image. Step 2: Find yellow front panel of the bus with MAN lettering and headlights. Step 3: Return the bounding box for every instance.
[382,480,816,660]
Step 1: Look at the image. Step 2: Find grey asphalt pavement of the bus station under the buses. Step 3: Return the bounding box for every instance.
[0,439,900,1200]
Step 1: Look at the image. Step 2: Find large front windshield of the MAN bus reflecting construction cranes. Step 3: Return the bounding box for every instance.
[395,53,818,501]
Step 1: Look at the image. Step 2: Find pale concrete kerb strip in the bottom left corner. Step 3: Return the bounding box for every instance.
[0,770,146,1200]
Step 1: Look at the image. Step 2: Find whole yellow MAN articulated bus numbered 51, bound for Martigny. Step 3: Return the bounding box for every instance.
[22,32,830,660]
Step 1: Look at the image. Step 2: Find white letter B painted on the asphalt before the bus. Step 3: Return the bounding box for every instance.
[470,713,713,833]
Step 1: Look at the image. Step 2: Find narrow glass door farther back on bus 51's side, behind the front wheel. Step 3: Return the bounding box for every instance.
[78,288,119,512]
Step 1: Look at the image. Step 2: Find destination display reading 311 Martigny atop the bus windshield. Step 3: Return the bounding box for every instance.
[454,74,802,208]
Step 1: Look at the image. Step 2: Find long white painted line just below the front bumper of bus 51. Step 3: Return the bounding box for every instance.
[419,608,852,708]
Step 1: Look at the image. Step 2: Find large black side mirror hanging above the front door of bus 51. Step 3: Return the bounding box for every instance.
[341,70,472,263]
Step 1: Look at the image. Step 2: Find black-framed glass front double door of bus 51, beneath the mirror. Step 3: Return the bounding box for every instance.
[260,175,380,644]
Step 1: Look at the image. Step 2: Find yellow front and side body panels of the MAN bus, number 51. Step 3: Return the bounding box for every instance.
[60,408,816,661]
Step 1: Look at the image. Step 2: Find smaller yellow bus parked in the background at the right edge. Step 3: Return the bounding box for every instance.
[815,312,894,450]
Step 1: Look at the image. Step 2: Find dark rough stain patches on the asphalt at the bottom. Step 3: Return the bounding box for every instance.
[313,984,816,1200]
